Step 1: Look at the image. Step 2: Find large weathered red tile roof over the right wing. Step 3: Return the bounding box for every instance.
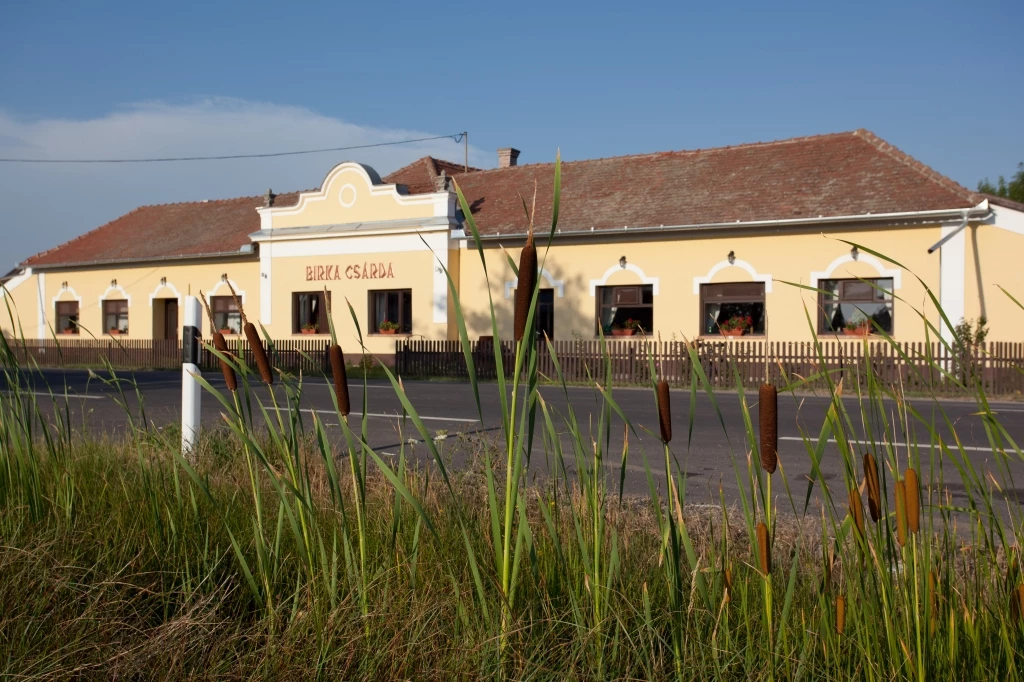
[456,130,982,235]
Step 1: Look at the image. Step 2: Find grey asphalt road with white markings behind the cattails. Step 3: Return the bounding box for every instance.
[6,370,1024,507]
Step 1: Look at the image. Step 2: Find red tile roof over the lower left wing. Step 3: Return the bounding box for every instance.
[23,194,298,266]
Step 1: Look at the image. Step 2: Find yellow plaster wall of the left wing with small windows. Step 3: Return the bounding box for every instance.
[0,260,259,339]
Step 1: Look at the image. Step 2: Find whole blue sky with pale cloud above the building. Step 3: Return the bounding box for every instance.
[0,0,1024,262]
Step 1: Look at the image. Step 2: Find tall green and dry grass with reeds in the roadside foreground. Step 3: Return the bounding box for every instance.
[0,156,1024,681]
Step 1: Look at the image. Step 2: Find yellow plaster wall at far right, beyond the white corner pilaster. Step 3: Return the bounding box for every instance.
[952,225,1024,341]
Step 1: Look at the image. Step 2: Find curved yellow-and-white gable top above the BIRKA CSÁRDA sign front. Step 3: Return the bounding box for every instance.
[263,164,434,229]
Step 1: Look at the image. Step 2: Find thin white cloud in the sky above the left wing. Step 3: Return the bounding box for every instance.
[0,98,493,266]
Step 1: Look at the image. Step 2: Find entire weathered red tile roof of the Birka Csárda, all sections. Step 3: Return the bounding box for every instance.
[23,130,983,266]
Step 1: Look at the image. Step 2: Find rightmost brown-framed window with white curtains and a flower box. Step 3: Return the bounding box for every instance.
[818,279,893,334]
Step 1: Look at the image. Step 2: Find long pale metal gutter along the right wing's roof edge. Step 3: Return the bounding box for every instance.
[471,200,991,241]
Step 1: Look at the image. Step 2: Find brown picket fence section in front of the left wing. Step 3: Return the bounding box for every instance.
[7,336,330,373]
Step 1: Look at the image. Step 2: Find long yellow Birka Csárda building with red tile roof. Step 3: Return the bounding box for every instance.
[4,130,1024,359]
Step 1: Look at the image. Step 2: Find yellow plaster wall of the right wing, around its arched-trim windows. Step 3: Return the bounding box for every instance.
[461,226,940,341]
